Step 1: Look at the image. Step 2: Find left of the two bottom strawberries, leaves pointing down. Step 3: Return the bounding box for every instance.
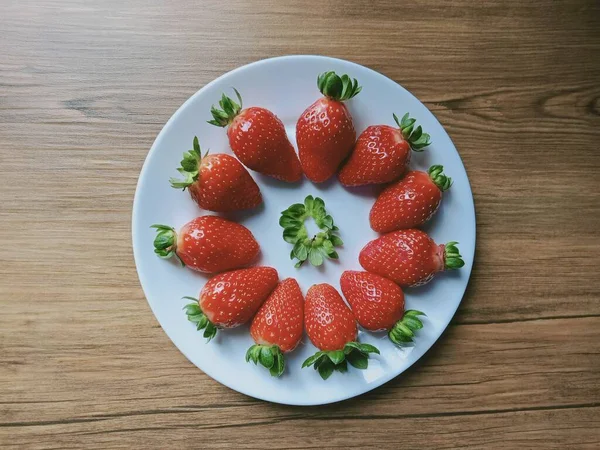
[246,278,304,377]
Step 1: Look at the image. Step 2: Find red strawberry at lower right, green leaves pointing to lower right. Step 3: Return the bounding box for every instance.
[340,270,425,345]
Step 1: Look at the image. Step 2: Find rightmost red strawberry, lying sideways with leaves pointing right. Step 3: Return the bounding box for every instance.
[358,229,465,286]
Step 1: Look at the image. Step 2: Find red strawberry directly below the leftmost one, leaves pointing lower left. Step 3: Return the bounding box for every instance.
[184,267,279,341]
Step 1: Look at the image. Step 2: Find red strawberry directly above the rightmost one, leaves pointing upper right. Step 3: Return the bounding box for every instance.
[369,166,452,233]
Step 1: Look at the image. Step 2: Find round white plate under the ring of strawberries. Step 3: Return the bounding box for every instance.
[132,56,475,405]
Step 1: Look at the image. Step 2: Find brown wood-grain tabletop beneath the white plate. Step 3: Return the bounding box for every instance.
[0,0,600,449]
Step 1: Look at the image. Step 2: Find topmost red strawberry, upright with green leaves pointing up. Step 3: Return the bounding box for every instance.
[296,72,361,183]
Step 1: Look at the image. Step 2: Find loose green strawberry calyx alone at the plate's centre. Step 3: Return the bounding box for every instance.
[279,195,344,268]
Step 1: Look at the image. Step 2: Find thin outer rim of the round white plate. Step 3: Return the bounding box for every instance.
[131,54,477,406]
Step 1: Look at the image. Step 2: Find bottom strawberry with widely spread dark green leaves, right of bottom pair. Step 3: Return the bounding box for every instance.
[302,284,379,380]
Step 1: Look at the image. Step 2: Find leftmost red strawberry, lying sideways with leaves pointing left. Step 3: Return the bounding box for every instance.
[151,216,260,272]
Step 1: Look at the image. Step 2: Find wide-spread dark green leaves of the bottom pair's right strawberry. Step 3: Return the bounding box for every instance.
[302,342,379,380]
